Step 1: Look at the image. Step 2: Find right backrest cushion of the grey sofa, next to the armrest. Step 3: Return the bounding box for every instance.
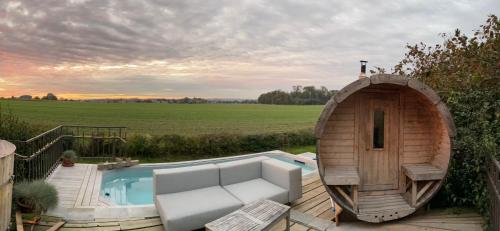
[217,156,269,186]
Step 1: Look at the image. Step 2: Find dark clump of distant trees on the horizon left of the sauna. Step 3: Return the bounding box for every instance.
[257,86,338,105]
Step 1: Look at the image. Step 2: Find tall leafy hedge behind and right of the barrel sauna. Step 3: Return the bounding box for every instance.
[382,15,500,227]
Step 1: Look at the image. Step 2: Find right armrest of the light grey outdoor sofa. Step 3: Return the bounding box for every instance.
[262,159,302,202]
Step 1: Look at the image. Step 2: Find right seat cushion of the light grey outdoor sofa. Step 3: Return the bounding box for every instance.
[223,178,288,204]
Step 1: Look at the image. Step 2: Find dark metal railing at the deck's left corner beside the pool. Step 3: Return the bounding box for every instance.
[11,125,127,182]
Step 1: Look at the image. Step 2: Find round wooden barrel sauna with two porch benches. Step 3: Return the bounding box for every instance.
[315,74,455,223]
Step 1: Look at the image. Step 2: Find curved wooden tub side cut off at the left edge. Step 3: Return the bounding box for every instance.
[0,140,16,231]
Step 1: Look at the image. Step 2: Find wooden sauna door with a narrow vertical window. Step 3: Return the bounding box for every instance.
[358,93,399,191]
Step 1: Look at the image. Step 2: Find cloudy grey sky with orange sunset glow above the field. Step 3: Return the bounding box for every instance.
[0,0,500,99]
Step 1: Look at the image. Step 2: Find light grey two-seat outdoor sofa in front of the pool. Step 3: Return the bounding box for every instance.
[153,156,302,231]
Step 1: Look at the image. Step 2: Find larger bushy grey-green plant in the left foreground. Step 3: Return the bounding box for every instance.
[14,180,59,215]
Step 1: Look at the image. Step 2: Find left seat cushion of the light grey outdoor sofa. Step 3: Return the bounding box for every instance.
[155,186,243,231]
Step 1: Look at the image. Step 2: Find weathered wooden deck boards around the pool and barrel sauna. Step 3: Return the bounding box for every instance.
[27,164,484,231]
